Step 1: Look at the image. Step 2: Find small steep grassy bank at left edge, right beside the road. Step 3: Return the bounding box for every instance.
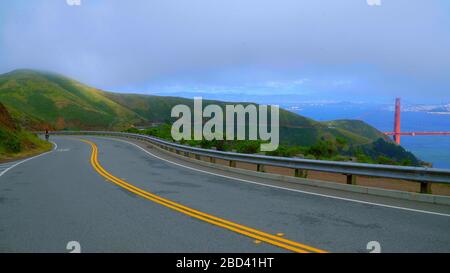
[0,103,52,162]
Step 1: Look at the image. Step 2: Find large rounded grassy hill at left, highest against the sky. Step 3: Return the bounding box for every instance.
[0,70,143,130]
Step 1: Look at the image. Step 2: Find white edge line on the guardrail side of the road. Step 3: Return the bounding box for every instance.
[92,138,450,217]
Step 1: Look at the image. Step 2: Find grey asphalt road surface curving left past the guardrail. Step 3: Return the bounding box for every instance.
[0,136,450,252]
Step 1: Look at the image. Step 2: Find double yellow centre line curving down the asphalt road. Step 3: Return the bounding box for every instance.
[81,139,325,253]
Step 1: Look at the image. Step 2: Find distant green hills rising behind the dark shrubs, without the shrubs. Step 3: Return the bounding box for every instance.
[0,70,420,165]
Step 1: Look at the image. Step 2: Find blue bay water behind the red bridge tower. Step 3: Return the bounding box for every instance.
[295,106,450,169]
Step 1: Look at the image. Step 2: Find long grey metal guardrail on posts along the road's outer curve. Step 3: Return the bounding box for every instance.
[46,131,450,193]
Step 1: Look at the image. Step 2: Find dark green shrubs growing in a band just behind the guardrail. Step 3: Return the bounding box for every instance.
[124,124,422,166]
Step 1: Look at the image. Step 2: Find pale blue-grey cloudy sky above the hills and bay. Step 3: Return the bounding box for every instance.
[0,0,450,103]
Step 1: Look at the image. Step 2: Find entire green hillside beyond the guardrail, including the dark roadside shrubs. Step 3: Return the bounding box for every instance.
[0,70,419,165]
